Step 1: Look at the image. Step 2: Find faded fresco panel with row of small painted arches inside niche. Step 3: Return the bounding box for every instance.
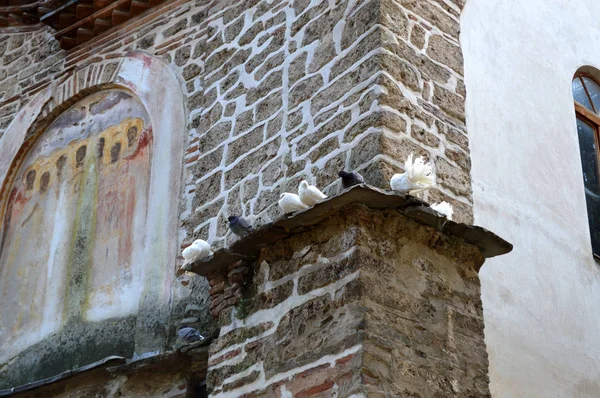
[0,90,152,362]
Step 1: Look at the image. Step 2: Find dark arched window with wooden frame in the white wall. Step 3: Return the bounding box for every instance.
[573,75,600,259]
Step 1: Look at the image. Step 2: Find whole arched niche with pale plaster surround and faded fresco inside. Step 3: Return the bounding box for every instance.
[0,53,185,386]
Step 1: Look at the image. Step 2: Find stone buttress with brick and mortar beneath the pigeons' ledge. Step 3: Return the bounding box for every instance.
[207,205,489,397]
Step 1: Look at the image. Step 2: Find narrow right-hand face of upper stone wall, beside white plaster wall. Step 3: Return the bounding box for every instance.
[372,0,473,223]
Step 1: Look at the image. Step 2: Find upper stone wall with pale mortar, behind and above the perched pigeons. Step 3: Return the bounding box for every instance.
[0,0,472,388]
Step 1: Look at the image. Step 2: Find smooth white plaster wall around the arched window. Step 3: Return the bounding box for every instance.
[461,0,600,397]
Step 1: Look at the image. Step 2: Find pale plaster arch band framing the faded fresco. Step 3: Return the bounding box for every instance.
[0,52,186,356]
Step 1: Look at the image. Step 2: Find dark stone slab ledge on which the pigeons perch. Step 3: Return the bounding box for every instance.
[186,184,513,276]
